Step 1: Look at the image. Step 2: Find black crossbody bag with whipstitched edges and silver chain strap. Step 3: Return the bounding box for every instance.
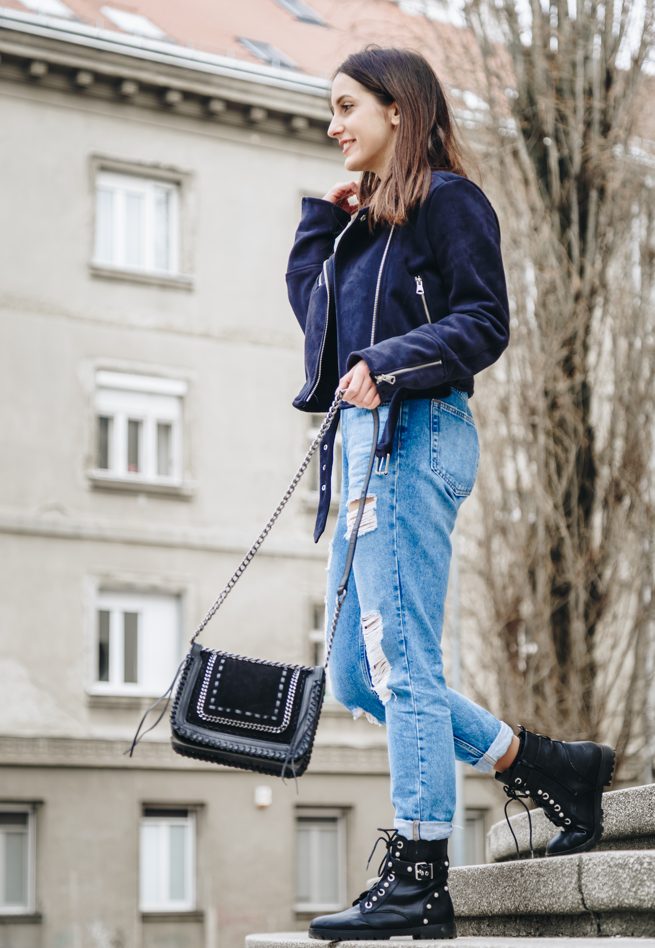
[129,391,379,777]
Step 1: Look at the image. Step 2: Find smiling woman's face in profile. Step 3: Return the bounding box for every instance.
[327,72,400,178]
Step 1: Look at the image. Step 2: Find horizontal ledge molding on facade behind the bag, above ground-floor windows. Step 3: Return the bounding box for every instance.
[0,736,389,777]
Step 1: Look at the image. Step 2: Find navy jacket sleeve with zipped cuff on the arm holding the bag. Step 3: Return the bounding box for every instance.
[347,178,509,395]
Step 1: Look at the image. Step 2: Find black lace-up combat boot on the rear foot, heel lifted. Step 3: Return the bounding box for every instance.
[496,725,616,856]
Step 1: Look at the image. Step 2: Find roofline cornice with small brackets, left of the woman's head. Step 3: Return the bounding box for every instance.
[0,7,330,135]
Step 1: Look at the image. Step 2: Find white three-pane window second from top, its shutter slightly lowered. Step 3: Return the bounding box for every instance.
[93,371,186,485]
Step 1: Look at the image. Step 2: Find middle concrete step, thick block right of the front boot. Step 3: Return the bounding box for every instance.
[449,850,655,938]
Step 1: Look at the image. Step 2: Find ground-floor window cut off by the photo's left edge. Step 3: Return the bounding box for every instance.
[0,804,34,915]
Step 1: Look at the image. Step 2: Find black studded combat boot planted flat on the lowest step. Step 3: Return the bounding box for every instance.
[309,830,457,941]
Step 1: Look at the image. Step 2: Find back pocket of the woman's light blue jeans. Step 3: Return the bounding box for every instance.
[430,396,480,497]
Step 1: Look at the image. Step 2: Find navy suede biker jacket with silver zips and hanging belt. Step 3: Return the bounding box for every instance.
[286,171,509,540]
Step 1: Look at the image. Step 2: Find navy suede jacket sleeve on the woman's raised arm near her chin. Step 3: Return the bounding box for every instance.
[286,197,350,332]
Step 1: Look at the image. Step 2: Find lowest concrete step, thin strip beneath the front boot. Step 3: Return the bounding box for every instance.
[246,932,655,948]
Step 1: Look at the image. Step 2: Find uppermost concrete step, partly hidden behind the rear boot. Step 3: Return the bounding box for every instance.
[487,784,655,862]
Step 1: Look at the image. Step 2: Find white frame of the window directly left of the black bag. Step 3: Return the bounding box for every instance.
[88,588,182,697]
